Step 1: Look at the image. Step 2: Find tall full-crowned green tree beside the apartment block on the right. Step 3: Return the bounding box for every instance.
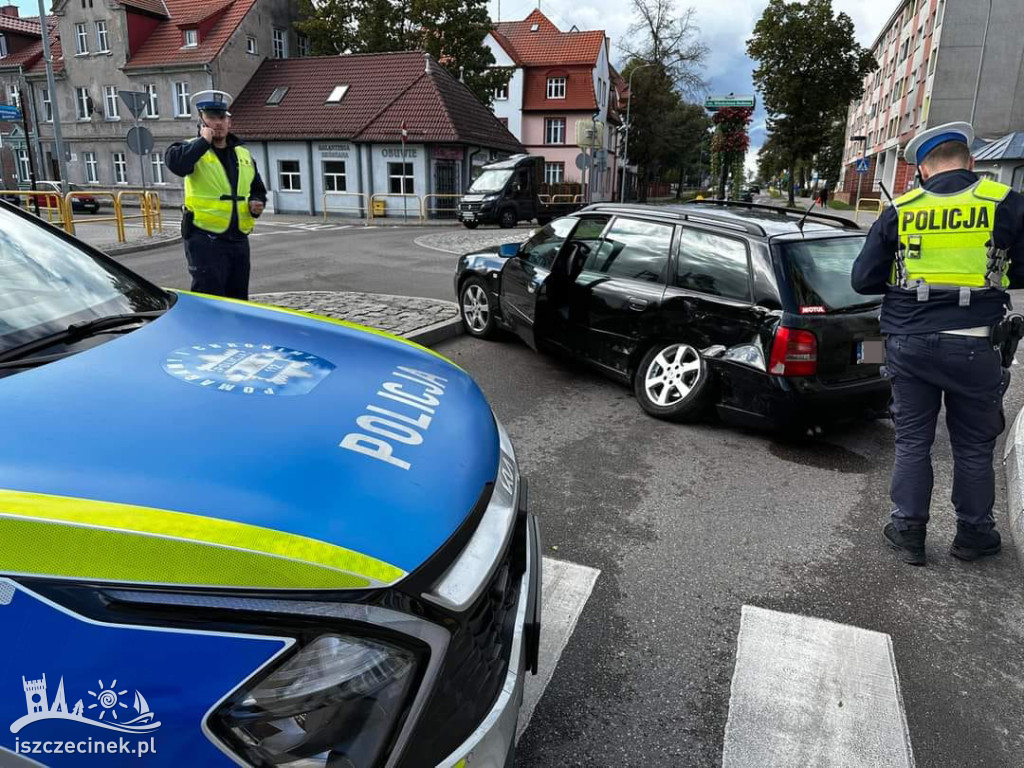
[746,0,878,205]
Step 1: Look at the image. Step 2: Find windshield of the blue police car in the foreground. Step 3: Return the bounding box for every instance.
[0,202,168,353]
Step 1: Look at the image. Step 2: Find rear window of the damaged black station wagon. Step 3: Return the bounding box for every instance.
[779,238,882,314]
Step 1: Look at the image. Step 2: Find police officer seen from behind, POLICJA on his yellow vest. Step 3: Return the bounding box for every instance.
[851,123,1024,565]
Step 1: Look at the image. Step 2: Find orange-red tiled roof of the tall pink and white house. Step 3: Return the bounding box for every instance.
[495,10,604,67]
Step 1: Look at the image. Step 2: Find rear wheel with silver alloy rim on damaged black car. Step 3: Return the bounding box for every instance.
[633,342,711,421]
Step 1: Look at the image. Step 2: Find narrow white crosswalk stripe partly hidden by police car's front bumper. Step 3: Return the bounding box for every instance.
[515,557,601,741]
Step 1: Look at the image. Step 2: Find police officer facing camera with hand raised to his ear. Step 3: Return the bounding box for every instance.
[164,90,266,299]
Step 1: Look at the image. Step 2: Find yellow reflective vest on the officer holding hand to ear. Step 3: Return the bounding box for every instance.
[185,146,256,234]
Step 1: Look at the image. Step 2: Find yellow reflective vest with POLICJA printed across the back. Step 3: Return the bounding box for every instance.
[890,179,1010,295]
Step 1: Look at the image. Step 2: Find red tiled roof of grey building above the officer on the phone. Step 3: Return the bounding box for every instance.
[125,0,256,71]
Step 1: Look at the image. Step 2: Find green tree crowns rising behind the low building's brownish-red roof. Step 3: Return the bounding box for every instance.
[295,0,511,104]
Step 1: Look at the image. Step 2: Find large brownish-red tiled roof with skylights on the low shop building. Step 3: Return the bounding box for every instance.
[231,51,522,152]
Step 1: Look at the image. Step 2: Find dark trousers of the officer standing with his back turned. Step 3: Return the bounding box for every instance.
[884,333,1006,530]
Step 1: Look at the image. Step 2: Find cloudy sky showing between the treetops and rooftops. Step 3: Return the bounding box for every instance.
[489,0,897,169]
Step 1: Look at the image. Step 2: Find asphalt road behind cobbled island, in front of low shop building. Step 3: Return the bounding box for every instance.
[118,219,529,300]
